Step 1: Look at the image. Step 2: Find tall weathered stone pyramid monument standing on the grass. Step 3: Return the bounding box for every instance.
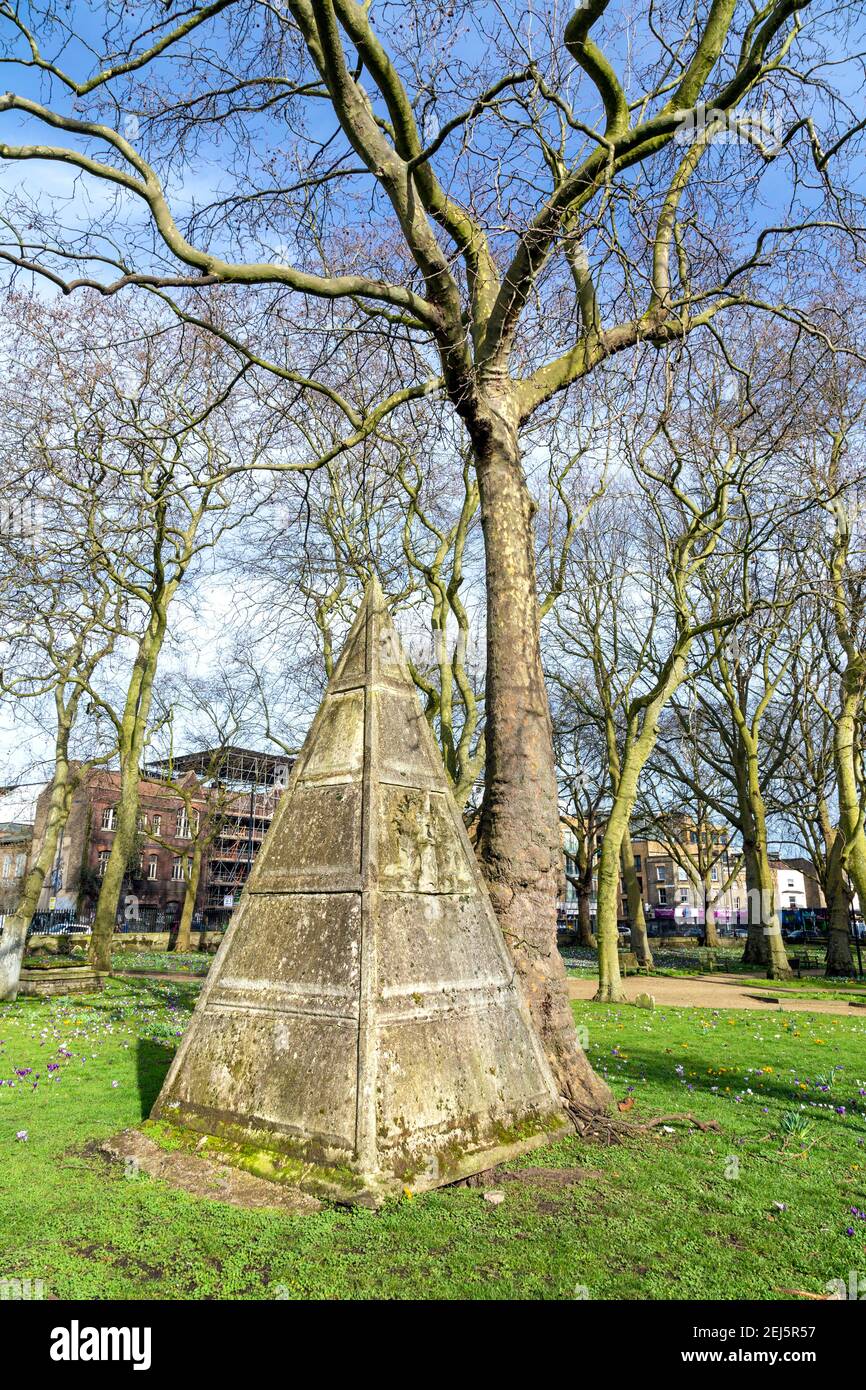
[153,581,566,1204]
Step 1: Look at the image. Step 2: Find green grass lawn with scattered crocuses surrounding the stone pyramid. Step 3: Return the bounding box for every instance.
[0,980,866,1298]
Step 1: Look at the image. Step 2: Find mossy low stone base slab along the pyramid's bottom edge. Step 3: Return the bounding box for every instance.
[140,1112,570,1208]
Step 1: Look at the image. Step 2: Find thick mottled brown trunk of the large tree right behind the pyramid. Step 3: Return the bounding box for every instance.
[473,404,612,1108]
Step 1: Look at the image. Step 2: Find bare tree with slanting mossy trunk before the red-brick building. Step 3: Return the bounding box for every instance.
[2,302,280,970]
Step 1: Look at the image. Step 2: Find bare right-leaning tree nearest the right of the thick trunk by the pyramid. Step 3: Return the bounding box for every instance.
[556,347,756,1001]
